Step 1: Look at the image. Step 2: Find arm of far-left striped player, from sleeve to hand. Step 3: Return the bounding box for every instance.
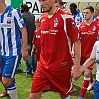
[13,10,28,60]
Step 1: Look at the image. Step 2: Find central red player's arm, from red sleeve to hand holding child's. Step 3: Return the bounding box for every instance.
[67,18,81,80]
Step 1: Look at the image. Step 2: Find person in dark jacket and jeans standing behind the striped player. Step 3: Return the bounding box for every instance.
[20,4,36,74]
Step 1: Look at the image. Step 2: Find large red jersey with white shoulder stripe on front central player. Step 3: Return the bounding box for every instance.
[40,9,79,71]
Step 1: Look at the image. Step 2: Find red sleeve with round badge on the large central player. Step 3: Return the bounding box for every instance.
[66,18,79,42]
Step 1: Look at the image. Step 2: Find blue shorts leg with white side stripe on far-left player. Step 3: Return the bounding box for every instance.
[2,55,21,78]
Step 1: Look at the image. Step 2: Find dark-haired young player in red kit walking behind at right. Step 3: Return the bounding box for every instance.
[78,6,99,99]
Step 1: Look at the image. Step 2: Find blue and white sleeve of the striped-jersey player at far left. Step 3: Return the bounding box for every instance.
[13,9,26,29]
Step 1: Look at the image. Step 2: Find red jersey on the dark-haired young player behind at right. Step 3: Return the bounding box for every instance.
[79,21,99,58]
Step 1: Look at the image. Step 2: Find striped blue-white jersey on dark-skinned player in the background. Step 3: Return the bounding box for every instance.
[72,11,84,25]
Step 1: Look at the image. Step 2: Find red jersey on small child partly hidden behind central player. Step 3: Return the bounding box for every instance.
[32,30,41,61]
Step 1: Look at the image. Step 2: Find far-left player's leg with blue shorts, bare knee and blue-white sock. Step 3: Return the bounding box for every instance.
[2,55,21,99]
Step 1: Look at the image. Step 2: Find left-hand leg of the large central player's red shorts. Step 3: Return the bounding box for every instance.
[31,66,51,93]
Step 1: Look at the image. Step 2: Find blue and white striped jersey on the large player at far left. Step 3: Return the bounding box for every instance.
[0,6,25,56]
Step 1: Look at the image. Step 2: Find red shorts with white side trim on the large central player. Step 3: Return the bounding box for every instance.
[31,64,73,96]
